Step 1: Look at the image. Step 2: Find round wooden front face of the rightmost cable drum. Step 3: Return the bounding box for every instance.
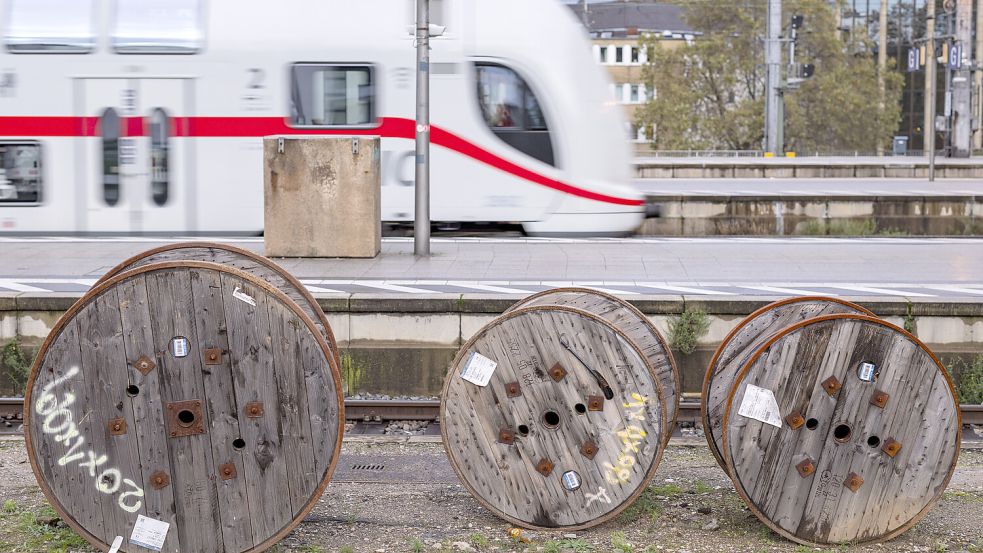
[721,314,961,546]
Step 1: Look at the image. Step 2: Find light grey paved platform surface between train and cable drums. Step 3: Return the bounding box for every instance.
[0,237,983,301]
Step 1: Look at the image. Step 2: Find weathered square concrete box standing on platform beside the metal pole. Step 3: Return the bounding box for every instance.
[263,136,382,257]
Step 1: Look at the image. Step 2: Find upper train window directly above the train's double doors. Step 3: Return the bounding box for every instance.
[110,0,205,54]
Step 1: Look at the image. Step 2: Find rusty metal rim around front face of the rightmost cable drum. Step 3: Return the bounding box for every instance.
[721,313,962,547]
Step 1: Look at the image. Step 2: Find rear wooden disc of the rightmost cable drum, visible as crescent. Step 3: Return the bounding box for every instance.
[700,296,874,468]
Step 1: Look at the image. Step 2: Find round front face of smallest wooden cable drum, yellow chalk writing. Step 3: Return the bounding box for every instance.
[440,305,666,529]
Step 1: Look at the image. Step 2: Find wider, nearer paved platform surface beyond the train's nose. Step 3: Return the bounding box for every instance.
[633,178,983,199]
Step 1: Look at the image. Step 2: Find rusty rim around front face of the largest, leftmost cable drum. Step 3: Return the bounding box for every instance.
[23,261,345,553]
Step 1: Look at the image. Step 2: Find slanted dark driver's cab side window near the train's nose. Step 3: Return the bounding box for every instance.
[475,63,556,165]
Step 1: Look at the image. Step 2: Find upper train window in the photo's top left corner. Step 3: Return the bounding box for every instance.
[3,0,96,54]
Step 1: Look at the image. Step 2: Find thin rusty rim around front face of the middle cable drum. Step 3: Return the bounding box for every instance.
[440,305,666,530]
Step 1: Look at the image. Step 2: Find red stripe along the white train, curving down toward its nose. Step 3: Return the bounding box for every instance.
[0,117,644,206]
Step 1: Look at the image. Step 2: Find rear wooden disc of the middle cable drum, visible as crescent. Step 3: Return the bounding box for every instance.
[506,288,681,445]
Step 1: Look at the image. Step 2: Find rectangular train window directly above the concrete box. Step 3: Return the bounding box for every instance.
[290,64,375,127]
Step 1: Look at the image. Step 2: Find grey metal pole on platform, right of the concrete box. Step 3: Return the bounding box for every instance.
[413,0,430,256]
